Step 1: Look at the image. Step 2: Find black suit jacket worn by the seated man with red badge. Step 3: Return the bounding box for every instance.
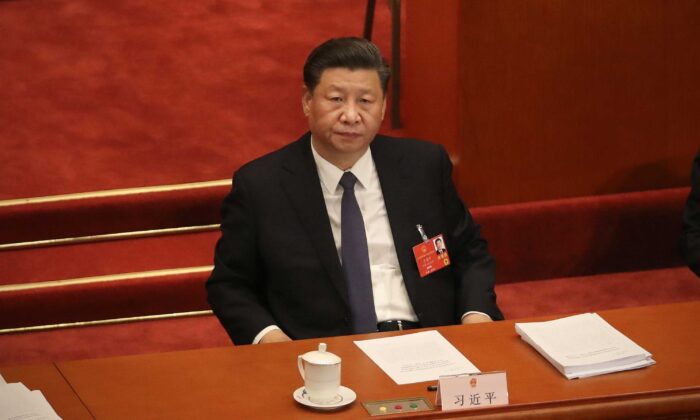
[207,133,503,344]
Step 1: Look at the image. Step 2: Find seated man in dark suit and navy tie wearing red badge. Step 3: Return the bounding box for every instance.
[207,38,503,344]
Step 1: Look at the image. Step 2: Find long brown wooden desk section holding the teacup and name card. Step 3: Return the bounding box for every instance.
[9,301,700,419]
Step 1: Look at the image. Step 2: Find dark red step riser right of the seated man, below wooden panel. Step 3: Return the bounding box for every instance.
[473,188,689,284]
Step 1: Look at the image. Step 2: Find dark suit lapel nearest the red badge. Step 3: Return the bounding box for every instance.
[371,136,420,294]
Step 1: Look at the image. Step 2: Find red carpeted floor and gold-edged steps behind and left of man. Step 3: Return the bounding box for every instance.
[0,0,398,364]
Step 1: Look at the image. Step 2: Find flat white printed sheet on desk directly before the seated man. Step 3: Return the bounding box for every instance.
[355,330,479,385]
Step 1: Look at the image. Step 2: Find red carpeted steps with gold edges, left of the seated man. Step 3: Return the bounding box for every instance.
[0,181,230,363]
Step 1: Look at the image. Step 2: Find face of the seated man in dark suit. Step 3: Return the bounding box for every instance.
[302,68,386,170]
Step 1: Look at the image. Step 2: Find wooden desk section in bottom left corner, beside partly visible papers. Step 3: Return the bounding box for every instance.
[0,363,93,420]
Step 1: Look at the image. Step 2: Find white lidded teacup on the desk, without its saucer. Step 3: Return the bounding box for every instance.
[297,343,340,404]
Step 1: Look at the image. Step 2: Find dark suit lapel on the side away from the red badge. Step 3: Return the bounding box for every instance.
[282,133,348,304]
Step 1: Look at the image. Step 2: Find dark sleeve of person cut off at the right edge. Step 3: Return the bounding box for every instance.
[681,151,700,277]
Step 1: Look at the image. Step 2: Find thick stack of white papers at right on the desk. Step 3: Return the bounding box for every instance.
[515,313,656,379]
